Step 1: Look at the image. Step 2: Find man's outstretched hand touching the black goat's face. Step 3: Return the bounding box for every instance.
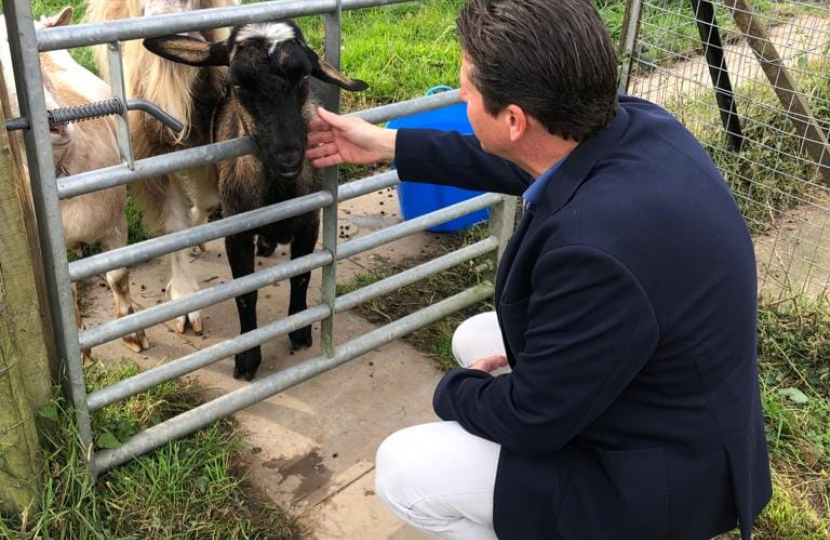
[305,107,398,168]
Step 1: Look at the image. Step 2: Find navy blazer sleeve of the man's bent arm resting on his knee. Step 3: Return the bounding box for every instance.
[433,247,658,457]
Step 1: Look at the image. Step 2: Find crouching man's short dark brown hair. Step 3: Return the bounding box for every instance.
[458,0,617,141]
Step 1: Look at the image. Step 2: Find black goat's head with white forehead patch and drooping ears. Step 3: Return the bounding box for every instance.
[144,21,367,178]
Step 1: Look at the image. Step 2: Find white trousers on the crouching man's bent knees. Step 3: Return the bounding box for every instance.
[375,312,505,540]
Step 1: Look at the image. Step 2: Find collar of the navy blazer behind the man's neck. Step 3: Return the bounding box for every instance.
[535,104,629,216]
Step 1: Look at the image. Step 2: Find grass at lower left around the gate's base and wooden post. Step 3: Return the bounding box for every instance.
[0,364,307,540]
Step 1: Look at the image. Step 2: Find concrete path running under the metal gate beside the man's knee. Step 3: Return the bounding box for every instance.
[81,190,448,540]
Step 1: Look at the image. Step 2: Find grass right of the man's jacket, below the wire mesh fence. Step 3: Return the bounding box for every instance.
[756,300,830,540]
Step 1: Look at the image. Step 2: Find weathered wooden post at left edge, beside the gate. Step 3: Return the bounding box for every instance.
[0,64,52,513]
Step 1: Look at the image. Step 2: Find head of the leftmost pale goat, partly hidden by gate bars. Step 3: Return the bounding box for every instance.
[0,7,73,151]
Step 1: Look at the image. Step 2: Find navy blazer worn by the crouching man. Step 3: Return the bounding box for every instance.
[395,96,771,540]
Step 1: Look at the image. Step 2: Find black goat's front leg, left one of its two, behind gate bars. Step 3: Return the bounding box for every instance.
[225,233,262,381]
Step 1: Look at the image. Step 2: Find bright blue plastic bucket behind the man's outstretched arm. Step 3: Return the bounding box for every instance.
[386,90,488,233]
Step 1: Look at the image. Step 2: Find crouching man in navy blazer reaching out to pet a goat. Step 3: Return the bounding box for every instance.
[307,0,771,540]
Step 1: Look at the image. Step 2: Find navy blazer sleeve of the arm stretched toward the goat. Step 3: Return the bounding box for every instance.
[395,129,533,195]
